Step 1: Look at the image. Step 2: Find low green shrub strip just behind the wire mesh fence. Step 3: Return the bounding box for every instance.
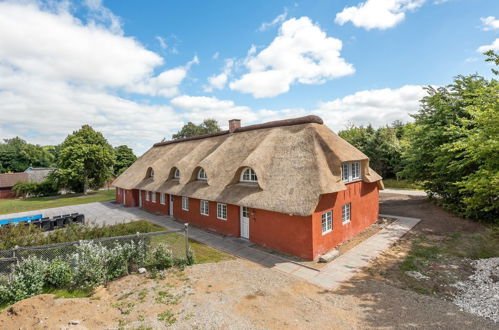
[0,220,163,249]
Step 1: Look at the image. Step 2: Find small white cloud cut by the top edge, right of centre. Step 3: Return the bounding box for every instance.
[335,0,426,30]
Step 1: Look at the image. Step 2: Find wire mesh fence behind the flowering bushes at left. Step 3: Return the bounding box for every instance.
[0,225,189,275]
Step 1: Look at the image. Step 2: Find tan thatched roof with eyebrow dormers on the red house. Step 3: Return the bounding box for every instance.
[113,116,382,216]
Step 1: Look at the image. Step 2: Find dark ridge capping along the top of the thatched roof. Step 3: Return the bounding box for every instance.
[153,115,324,147]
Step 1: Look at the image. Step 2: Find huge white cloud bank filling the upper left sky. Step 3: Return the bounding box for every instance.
[0,1,199,153]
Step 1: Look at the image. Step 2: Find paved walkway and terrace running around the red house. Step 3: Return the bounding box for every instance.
[0,202,420,289]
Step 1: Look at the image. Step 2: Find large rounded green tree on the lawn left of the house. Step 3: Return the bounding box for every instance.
[57,125,115,193]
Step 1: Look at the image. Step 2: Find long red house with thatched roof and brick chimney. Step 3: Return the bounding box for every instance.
[113,116,383,259]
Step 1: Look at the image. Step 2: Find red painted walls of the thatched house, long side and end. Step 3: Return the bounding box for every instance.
[116,181,379,259]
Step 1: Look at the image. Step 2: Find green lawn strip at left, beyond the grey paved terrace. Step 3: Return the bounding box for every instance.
[0,189,115,214]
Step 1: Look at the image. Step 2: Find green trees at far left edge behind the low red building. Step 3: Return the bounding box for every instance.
[0,137,56,173]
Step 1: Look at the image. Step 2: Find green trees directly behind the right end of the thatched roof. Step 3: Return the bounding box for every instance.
[338,121,404,178]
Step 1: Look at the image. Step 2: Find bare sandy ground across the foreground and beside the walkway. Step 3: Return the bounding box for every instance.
[0,196,497,329]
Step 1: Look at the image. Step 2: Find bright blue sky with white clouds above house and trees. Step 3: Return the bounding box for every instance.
[0,0,499,154]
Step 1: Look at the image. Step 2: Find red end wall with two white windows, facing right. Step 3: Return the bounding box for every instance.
[312,181,379,259]
